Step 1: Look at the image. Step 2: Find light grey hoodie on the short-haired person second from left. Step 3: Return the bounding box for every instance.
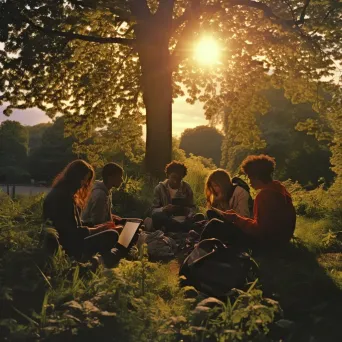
[82,181,112,226]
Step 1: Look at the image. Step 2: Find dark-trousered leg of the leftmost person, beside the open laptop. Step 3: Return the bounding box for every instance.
[84,229,119,257]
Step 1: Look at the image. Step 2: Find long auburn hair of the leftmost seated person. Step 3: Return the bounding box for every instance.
[52,159,95,208]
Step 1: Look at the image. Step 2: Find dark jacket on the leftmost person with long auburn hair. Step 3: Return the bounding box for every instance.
[43,188,90,258]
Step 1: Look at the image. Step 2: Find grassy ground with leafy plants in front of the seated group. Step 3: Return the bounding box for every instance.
[0,188,342,342]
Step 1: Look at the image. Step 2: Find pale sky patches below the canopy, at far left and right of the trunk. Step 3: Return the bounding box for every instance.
[0,97,208,136]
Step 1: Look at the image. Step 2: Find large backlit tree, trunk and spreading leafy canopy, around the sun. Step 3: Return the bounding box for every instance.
[0,0,342,173]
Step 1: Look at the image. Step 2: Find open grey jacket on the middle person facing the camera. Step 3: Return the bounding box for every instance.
[152,179,195,215]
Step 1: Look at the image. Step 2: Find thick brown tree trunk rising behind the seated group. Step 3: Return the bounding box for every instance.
[138,26,172,178]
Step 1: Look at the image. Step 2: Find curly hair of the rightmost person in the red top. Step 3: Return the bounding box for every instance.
[241,154,276,183]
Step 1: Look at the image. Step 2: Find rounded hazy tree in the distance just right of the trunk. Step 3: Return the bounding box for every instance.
[179,126,223,165]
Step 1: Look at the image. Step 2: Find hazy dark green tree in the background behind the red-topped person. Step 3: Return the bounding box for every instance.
[257,90,335,187]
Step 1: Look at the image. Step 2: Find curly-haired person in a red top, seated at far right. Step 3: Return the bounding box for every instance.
[202,155,296,249]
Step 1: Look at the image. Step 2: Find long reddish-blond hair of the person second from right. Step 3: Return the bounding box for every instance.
[205,169,234,206]
